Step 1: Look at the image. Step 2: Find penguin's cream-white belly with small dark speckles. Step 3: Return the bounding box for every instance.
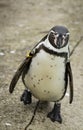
[24,50,65,101]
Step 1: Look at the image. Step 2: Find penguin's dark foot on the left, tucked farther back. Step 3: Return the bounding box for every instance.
[20,90,32,105]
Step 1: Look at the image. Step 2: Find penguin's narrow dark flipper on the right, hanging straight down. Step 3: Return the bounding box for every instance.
[67,62,73,104]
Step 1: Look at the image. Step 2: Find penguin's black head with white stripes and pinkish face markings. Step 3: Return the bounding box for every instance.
[48,26,69,49]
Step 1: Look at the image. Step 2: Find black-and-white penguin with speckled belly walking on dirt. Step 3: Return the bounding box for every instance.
[9,26,73,123]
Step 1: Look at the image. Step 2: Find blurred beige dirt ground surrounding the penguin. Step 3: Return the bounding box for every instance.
[0,0,83,130]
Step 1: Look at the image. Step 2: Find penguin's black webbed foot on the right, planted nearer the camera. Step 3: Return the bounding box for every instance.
[47,103,62,124]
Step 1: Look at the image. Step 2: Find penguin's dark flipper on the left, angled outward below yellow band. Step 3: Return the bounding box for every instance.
[9,57,31,93]
